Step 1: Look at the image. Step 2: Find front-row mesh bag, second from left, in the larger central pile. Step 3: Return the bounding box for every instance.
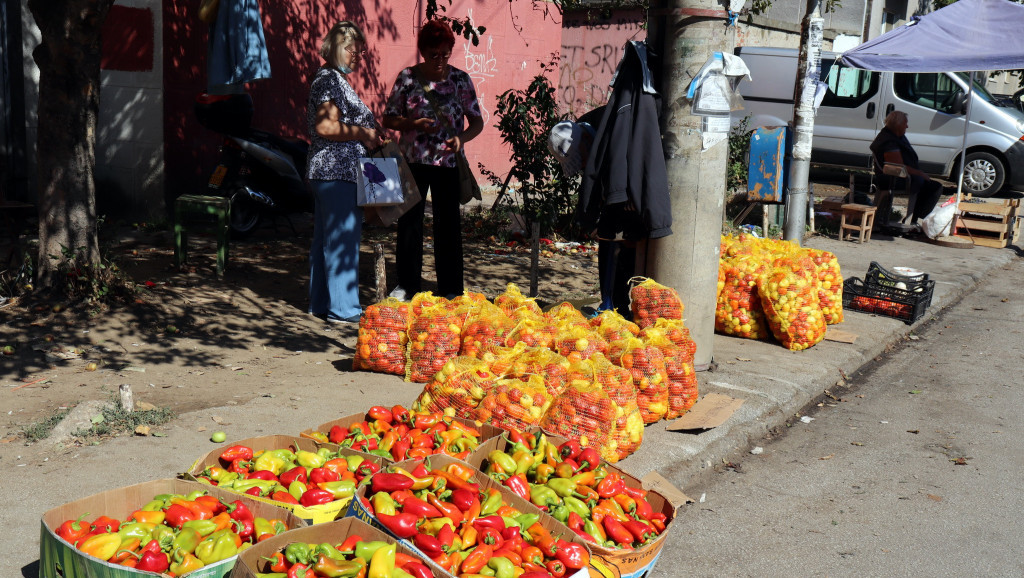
[473,375,554,429]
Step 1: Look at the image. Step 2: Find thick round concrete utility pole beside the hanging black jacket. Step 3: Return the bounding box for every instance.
[646,0,735,370]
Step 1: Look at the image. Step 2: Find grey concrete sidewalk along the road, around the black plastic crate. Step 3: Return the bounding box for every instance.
[621,236,1017,489]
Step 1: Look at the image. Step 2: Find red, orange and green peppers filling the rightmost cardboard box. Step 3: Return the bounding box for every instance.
[484,431,668,548]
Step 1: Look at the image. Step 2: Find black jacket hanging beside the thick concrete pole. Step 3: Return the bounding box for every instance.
[577,41,672,239]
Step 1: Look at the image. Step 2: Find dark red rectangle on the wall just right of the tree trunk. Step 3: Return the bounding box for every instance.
[99,5,154,72]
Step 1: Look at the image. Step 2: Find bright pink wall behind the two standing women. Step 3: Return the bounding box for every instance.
[164,0,561,199]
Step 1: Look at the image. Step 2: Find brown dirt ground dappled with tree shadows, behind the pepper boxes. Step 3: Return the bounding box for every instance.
[0,204,598,463]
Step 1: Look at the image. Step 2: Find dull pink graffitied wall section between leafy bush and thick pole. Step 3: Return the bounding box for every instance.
[558,10,647,117]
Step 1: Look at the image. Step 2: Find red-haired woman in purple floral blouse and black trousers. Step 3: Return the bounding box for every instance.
[382,20,483,299]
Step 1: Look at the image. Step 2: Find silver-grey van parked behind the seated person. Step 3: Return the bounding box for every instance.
[734,47,1024,197]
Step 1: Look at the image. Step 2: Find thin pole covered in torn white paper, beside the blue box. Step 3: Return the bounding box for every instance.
[782,0,824,245]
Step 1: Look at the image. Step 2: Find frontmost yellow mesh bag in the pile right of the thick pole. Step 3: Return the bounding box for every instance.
[758,257,825,352]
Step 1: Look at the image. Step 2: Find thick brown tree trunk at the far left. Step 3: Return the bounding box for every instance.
[29,0,114,288]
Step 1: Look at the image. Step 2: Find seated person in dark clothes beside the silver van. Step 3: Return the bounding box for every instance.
[870,111,942,224]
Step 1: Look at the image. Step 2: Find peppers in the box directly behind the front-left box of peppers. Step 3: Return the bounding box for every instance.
[196,446,370,507]
